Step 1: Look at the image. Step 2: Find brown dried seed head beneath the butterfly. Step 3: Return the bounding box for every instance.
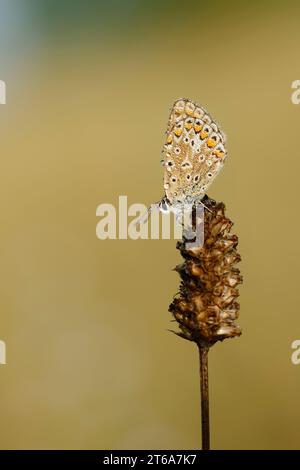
[169,196,242,346]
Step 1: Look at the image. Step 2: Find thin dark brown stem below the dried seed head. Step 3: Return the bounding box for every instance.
[198,344,210,450]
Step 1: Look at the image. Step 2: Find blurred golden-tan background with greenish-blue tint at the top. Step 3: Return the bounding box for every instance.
[0,0,300,449]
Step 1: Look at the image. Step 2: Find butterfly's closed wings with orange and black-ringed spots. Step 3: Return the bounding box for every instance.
[164,99,227,203]
